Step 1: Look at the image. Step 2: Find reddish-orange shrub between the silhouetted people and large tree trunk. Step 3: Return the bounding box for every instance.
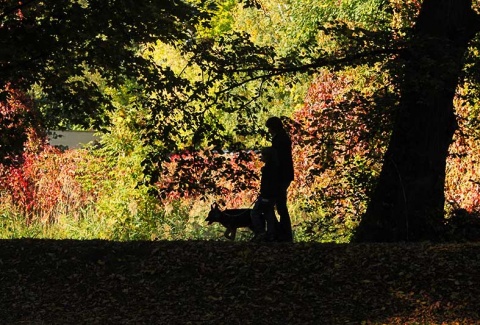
[284,68,390,237]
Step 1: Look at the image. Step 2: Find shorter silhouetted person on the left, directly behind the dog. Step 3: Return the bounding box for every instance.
[251,147,279,241]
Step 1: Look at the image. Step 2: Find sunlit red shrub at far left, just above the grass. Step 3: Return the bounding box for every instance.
[0,146,101,224]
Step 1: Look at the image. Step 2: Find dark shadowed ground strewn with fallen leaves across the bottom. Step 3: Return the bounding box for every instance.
[0,240,480,325]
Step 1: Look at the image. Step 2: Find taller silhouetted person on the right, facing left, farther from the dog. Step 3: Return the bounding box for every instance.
[265,116,294,242]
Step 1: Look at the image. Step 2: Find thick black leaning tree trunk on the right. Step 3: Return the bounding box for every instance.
[356,0,478,241]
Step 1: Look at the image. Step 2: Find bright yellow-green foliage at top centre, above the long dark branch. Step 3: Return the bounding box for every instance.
[235,0,391,56]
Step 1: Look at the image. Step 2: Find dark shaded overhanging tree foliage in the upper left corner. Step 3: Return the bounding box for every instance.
[0,0,206,132]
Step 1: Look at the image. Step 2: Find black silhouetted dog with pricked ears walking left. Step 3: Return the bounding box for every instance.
[205,203,253,240]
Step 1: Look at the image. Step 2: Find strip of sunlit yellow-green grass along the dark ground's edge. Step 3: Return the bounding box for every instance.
[0,200,353,243]
